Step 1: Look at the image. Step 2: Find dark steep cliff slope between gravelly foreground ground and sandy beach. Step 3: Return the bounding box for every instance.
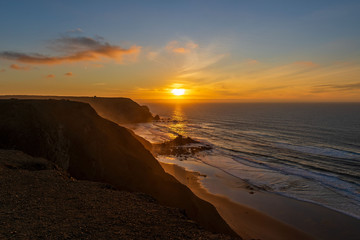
[0,99,236,236]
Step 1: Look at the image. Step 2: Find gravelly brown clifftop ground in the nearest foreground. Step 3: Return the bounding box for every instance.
[0,150,233,240]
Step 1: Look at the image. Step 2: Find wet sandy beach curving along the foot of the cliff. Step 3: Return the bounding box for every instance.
[159,161,360,239]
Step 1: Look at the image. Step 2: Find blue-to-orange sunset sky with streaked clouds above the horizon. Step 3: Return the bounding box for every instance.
[0,0,360,102]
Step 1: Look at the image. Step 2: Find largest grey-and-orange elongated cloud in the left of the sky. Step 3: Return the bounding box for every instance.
[0,36,141,64]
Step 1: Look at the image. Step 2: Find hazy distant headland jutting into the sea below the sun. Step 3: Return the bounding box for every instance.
[0,95,154,124]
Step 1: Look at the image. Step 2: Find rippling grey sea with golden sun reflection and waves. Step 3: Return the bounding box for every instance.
[131,102,360,219]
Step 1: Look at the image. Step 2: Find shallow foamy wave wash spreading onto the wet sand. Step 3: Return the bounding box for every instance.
[198,155,360,219]
